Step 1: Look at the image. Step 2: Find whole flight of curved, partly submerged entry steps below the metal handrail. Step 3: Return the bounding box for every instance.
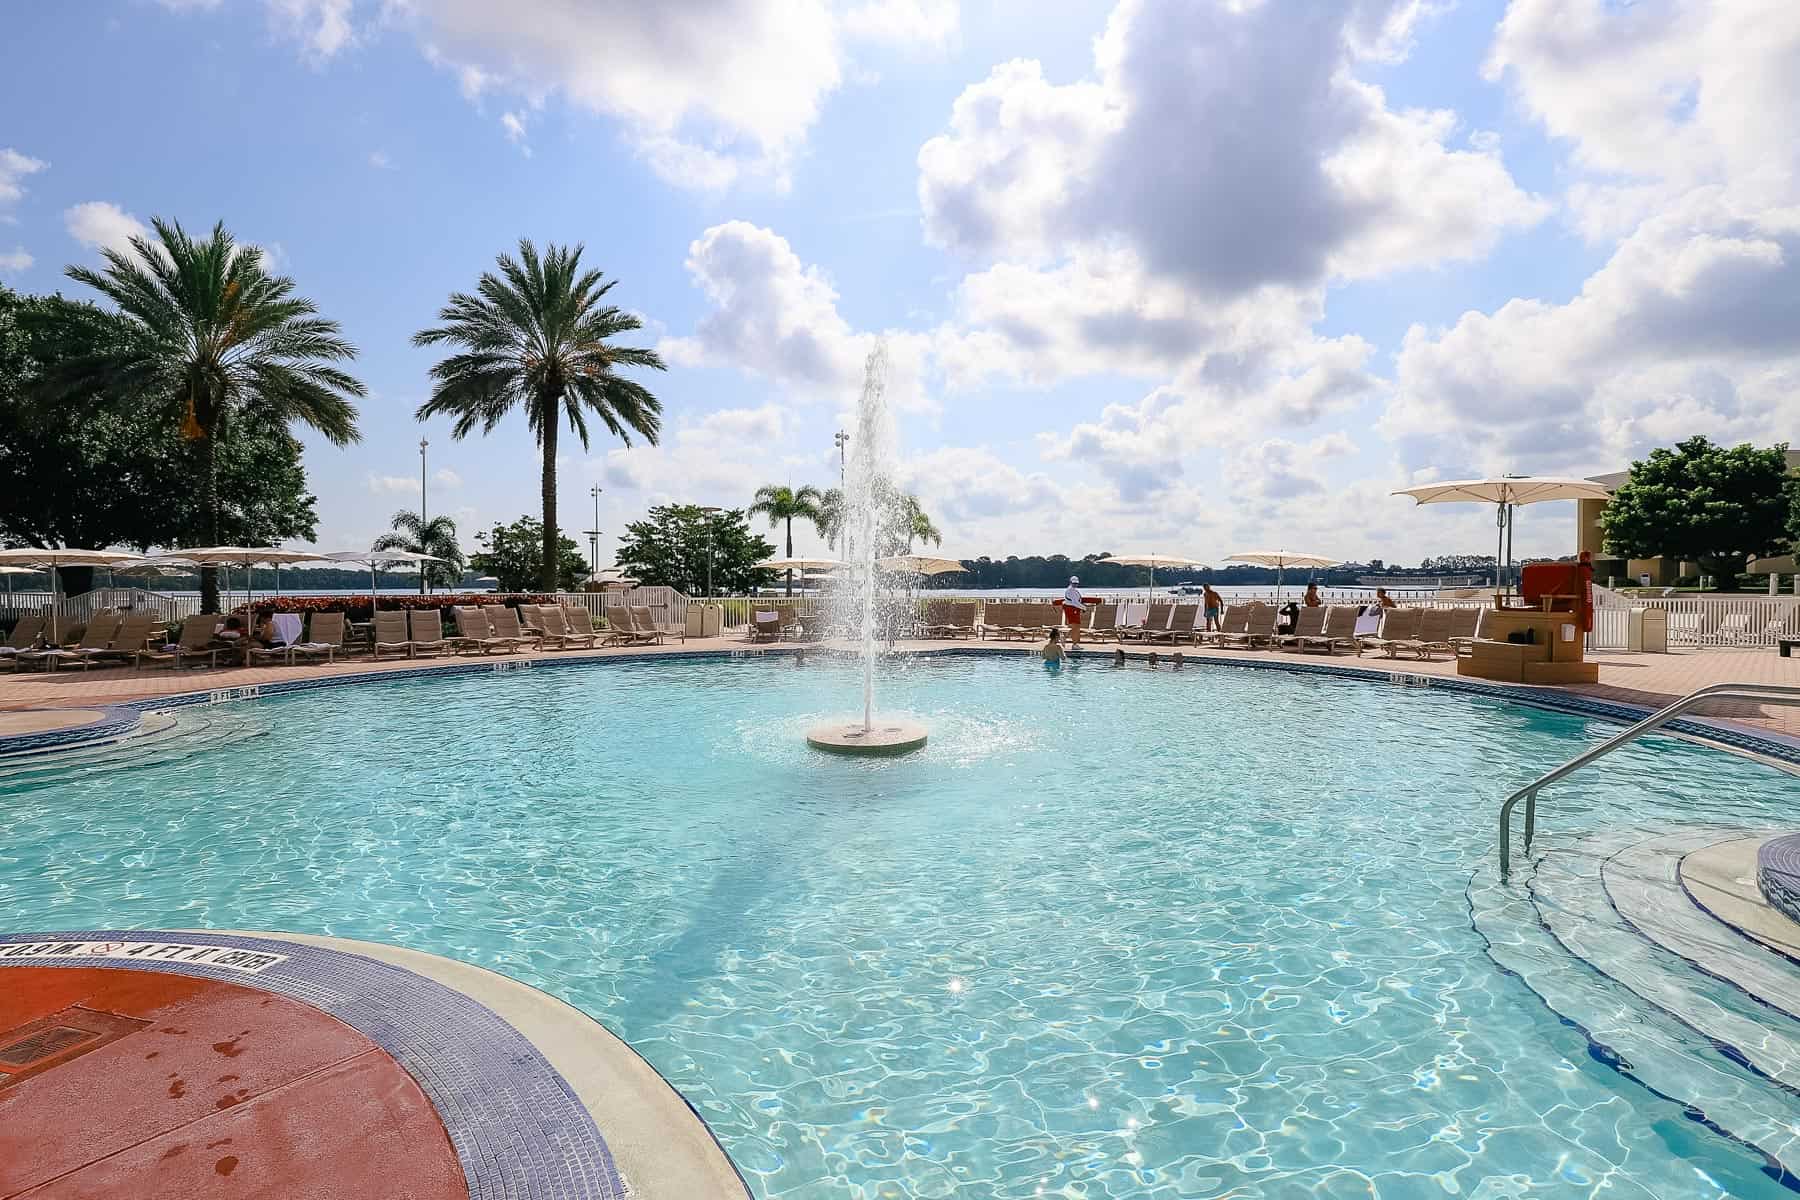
[1469,826,1800,1186]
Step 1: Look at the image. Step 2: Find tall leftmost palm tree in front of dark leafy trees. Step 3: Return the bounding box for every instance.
[41,218,365,612]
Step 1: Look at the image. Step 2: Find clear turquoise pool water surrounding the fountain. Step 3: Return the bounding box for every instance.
[0,658,1793,1200]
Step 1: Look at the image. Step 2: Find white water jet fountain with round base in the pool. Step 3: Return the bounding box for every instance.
[806,342,925,754]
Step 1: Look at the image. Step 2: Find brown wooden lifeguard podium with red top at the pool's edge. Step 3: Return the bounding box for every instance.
[1456,563,1600,684]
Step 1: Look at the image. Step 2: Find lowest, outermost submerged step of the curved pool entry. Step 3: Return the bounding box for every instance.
[1469,849,1800,1171]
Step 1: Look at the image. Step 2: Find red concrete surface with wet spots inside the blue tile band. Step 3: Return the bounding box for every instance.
[0,966,468,1200]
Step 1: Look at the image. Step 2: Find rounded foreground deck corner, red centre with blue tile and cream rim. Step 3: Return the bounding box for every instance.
[0,930,749,1200]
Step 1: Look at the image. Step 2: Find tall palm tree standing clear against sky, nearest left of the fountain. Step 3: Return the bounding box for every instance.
[412,239,664,592]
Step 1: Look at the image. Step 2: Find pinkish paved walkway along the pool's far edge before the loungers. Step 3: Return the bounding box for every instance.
[0,635,1800,738]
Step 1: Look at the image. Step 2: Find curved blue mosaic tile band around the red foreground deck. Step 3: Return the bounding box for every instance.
[0,930,628,1200]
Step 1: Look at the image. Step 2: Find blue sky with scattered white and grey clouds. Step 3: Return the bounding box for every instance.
[0,0,1800,565]
